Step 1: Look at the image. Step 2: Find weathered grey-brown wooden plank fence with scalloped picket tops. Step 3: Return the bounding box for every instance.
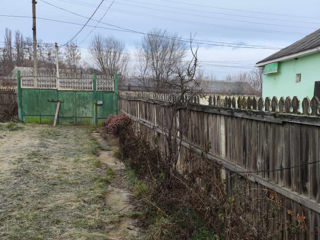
[119,92,320,239]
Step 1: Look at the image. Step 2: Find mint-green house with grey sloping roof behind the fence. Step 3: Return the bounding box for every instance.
[256,29,320,100]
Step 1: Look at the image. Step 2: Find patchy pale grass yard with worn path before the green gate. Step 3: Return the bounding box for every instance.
[0,124,137,240]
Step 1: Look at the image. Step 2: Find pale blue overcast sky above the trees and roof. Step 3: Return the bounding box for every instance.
[0,0,320,79]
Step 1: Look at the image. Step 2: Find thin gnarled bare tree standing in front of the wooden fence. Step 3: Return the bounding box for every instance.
[158,40,204,182]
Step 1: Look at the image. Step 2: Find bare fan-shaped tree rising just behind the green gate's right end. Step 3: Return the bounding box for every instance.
[90,35,129,76]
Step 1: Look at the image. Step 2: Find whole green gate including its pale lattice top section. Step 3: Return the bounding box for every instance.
[17,72,118,125]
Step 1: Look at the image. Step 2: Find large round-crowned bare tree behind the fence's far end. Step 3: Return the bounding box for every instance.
[139,30,186,88]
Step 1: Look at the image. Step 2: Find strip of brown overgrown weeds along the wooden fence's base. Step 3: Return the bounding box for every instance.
[120,124,305,240]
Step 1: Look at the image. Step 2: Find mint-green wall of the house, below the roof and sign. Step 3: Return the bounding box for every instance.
[262,53,320,100]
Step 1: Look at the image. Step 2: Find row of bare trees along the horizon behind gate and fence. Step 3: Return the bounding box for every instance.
[0,29,262,91]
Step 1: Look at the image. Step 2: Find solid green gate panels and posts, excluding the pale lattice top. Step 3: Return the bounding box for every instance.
[17,72,118,124]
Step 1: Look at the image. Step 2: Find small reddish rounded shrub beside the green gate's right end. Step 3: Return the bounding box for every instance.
[104,114,131,136]
